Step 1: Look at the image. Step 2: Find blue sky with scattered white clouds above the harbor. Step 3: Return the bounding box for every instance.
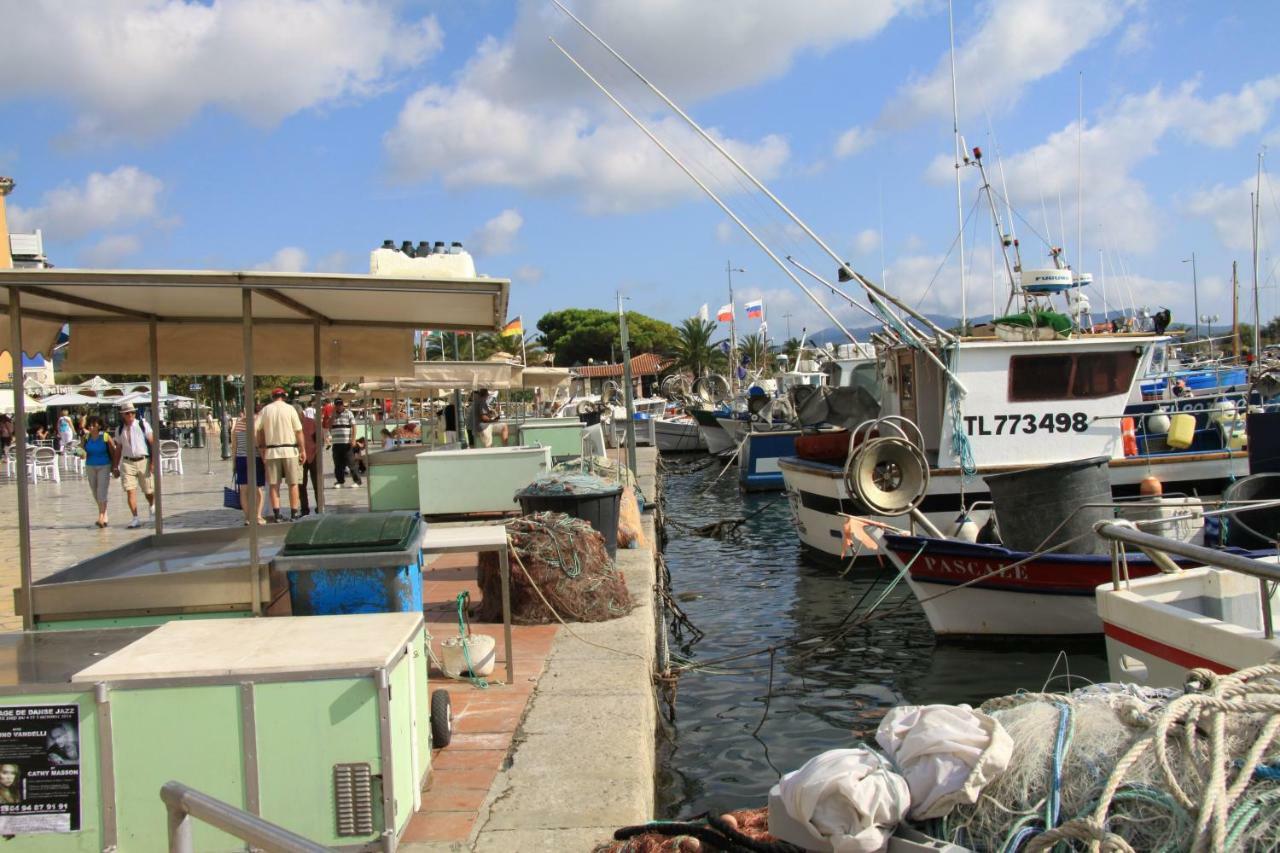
[0,0,1280,337]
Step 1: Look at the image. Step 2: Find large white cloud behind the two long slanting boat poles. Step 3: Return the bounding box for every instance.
[384,0,923,213]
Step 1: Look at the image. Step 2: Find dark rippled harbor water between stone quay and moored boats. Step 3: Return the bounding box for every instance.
[658,456,1107,817]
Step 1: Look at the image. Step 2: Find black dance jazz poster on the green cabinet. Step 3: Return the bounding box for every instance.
[0,704,81,835]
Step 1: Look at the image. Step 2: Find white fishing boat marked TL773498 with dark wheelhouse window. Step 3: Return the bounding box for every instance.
[778,334,1248,558]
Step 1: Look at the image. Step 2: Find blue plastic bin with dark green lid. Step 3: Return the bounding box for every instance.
[271,512,422,616]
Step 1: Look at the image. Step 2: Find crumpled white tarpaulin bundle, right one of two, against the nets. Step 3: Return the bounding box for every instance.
[876,704,1014,821]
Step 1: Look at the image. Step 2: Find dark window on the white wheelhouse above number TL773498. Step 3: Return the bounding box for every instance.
[1009,351,1138,402]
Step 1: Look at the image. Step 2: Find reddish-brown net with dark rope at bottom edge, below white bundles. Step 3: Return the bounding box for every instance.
[591,808,778,853]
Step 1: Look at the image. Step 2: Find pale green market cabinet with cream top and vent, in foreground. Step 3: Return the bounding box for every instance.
[0,613,430,853]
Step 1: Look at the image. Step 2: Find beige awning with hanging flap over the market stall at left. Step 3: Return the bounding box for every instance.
[0,263,511,378]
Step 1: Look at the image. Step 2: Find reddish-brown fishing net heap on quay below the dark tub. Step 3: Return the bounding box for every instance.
[476,512,631,625]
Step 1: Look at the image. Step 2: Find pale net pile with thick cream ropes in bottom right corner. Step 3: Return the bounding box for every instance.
[932,665,1280,850]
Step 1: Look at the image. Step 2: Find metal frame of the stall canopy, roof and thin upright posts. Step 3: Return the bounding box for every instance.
[0,269,511,630]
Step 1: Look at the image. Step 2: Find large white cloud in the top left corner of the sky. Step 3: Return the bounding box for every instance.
[0,0,442,141]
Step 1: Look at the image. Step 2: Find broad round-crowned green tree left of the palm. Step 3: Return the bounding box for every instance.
[538,309,677,365]
